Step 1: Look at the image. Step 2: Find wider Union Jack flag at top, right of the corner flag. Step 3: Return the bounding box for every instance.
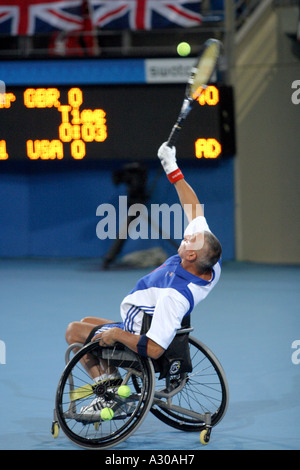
[90,0,202,30]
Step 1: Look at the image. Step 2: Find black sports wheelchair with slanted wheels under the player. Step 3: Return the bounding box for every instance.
[51,327,229,449]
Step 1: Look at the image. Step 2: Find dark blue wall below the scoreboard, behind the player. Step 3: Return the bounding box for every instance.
[0,159,234,259]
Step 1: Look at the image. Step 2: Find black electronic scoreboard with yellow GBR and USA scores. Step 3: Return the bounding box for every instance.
[0,83,235,161]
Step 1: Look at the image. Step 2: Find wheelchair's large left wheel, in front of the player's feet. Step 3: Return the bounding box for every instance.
[55,343,155,449]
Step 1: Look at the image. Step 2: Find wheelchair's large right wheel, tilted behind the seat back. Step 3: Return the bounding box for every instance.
[151,336,229,432]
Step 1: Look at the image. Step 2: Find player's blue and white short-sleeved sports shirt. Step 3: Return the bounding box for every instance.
[120,216,221,349]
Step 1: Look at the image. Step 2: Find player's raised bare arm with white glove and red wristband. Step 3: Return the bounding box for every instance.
[158,142,203,222]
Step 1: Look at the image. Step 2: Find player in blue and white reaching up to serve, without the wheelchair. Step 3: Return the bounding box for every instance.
[66,143,222,413]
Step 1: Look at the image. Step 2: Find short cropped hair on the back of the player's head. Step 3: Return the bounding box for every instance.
[196,231,222,274]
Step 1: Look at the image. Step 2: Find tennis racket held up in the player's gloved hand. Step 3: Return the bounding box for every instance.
[167,39,222,147]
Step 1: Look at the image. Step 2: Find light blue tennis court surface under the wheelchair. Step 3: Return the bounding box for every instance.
[0,260,300,451]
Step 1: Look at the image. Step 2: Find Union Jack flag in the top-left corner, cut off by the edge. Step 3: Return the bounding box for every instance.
[0,0,83,36]
